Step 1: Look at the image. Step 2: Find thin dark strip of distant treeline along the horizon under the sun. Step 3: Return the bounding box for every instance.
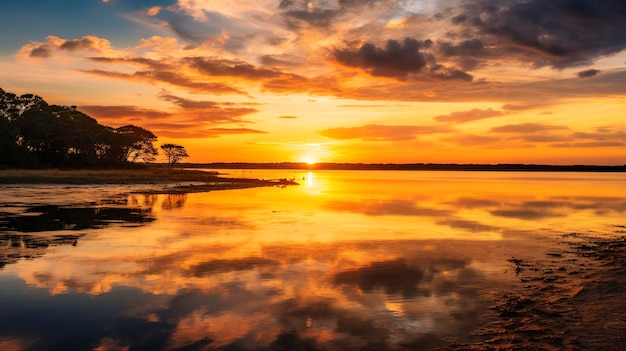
[180,162,626,172]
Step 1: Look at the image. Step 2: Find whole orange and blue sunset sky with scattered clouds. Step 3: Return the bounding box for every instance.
[0,0,626,165]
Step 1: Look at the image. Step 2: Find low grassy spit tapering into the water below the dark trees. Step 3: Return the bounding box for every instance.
[0,168,298,194]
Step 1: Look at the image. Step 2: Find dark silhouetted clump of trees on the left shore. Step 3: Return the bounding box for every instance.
[0,88,188,168]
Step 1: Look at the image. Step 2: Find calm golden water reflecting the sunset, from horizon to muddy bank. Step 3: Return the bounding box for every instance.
[0,170,626,351]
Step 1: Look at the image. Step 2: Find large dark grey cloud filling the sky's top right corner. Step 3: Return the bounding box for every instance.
[452,0,626,68]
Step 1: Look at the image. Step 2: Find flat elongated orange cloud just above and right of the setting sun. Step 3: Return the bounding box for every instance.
[317,124,453,141]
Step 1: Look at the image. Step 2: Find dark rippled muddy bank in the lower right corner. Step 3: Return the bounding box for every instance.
[449,231,626,350]
